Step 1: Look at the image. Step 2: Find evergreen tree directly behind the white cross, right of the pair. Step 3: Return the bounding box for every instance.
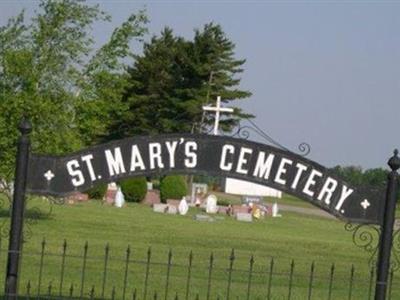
[192,23,252,131]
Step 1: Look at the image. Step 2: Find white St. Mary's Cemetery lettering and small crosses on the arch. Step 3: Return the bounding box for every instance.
[56,136,366,220]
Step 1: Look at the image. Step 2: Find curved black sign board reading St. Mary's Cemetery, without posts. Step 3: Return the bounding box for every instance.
[27,134,383,224]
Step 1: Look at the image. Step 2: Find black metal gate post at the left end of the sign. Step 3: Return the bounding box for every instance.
[5,119,32,299]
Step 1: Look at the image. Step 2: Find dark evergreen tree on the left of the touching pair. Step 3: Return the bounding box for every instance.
[110,28,191,138]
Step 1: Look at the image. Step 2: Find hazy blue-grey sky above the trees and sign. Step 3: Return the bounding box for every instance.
[0,0,400,169]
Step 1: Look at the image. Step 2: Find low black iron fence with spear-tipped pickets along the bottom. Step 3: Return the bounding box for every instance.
[0,240,400,300]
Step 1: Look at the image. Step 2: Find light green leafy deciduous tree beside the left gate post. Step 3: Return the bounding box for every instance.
[0,0,147,197]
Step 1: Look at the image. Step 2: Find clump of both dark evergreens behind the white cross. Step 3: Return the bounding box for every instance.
[106,23,251,138]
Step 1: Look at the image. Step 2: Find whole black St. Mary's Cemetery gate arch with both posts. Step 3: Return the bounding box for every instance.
[5,120,400,300]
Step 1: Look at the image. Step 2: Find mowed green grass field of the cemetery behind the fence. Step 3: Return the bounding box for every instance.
[0,197,400,299]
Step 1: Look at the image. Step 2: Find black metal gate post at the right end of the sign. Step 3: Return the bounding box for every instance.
[375,149,400,300]
